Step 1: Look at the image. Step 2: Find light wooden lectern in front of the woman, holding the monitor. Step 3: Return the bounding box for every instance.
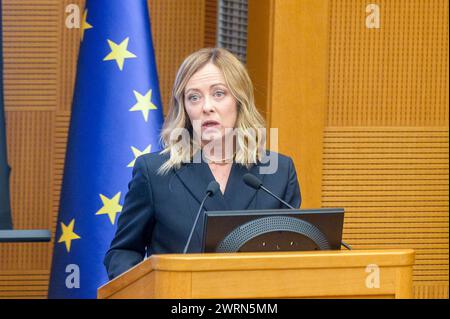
[98,249,414,298]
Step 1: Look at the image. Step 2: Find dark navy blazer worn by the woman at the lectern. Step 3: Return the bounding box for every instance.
[104,153,301,279]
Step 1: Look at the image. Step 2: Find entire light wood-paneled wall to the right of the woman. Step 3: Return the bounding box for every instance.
[247,0,449,298]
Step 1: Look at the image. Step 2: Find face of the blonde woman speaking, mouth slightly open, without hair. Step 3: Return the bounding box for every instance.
[184,62,237,143]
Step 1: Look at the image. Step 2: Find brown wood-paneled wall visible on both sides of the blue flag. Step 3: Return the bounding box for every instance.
[0,0,215,298]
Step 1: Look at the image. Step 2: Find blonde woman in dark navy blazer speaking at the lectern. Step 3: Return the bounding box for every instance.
[104,48,301,279]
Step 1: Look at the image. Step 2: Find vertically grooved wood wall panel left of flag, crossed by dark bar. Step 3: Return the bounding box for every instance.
[0,111,52,272]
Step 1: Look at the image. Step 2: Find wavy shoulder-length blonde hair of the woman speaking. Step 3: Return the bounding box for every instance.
[158,48,266,174]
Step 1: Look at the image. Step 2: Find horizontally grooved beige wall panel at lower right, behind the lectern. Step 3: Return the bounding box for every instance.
[322,127,449,298]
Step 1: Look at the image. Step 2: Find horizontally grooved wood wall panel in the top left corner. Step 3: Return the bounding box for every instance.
[2,0,59,112]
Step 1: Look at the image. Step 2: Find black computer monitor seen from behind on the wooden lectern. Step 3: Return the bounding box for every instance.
[202,208,344,253]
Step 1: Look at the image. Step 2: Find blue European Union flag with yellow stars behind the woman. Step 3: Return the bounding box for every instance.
[48,0,163,298]
